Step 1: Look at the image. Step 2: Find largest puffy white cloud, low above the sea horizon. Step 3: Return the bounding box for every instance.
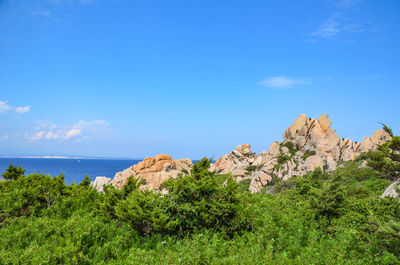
[26,120,109,141]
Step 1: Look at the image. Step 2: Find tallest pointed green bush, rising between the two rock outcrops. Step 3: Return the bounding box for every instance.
[160,158,247,235]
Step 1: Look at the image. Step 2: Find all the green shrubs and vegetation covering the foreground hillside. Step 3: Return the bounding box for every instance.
[0,137,400,264]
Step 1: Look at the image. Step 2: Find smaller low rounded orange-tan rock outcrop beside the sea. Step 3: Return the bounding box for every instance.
[112,155,193,190]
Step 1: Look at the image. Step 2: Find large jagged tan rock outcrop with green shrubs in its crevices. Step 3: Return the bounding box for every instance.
[212,114,391,192]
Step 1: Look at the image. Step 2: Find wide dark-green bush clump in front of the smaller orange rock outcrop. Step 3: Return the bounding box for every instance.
[99,159,247,236]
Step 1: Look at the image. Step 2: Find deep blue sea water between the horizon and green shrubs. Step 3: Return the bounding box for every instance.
[0,158,139,184]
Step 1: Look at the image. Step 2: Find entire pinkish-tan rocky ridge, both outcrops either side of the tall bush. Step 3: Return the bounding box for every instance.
[92,114,392,193]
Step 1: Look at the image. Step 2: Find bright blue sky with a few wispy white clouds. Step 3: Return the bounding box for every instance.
[0,0,400,159]
